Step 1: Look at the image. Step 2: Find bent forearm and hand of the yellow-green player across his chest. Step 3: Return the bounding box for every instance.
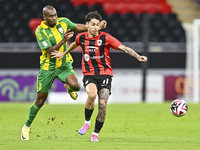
[46,29,74,55]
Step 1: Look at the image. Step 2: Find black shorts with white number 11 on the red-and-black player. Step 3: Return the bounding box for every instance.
[83,75,112,91]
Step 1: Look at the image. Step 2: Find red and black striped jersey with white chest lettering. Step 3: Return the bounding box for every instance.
[75,32,122,76]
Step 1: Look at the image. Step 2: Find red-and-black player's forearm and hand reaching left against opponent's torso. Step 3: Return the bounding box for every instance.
[51,42,77,62]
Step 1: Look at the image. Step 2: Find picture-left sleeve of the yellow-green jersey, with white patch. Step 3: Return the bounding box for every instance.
[35,27,52,49]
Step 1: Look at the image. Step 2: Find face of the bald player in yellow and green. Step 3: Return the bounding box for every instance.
[43,9,57,27]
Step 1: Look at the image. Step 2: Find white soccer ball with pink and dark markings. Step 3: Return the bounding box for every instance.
[170,99,188,117]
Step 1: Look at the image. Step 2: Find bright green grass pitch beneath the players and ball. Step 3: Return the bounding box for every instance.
[0,103,200,150]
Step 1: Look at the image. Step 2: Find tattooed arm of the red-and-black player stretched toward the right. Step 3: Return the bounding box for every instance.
[118,44,147,62]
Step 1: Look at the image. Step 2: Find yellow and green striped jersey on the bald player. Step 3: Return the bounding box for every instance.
[35,17,76,70]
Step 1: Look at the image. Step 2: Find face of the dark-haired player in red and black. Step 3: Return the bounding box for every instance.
[87,19,100,37]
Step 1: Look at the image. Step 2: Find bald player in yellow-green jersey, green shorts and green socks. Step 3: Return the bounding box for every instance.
[21,5,107,140]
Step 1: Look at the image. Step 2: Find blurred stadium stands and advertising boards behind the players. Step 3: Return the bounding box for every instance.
[0,0,200,103]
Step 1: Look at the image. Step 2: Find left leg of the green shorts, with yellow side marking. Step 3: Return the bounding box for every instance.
[37,70,56,93]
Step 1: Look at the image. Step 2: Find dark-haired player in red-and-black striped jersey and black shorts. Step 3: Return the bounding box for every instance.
[51,11,147,141]
